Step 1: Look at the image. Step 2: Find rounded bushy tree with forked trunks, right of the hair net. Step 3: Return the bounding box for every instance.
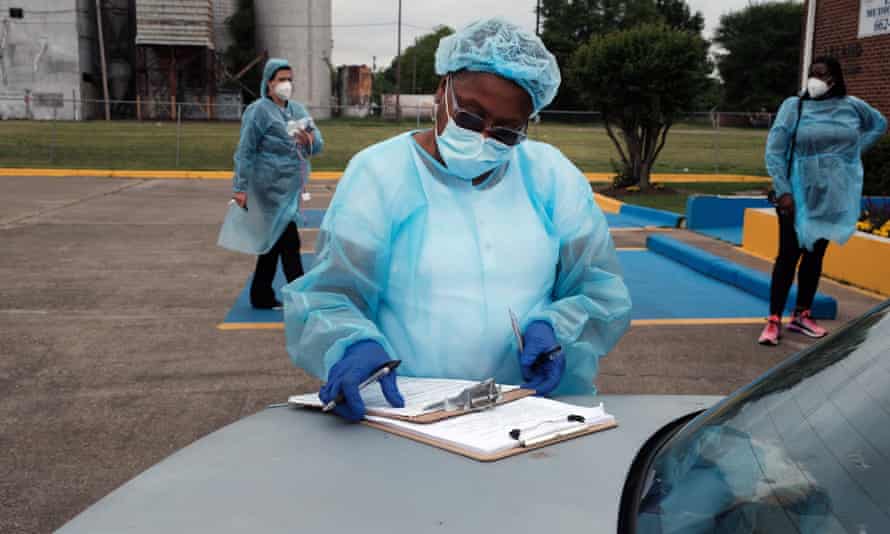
[568,24,710,190]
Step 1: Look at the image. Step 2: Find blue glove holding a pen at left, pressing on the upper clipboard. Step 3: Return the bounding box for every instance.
[318,340,405,421]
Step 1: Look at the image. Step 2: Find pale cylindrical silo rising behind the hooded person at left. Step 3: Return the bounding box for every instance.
[254,0,333,118]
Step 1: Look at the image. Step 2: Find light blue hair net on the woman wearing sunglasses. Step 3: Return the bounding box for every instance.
[436,18,562,113]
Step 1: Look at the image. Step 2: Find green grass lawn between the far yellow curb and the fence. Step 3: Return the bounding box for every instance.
[0,119,767,175]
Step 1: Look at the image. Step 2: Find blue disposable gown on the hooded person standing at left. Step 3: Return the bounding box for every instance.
[219,59,324,254]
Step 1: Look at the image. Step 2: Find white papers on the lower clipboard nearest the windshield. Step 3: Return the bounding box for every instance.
[367,397,615,454]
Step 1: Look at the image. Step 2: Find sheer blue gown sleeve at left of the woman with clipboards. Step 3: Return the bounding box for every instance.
[283,159,394,379]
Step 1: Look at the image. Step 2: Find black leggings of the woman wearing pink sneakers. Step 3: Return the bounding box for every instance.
[769,213,828,315]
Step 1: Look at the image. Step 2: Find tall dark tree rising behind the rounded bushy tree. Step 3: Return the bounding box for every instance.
[541,0,704,109]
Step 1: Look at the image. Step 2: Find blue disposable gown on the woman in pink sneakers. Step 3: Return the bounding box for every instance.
[766,96,887,250]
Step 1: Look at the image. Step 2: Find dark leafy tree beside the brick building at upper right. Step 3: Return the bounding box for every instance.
[714,2,803,111]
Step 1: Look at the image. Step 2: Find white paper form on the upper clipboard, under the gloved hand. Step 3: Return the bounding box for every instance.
[287,377,519,417]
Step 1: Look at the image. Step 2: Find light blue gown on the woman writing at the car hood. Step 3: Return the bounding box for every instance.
[283,134,631,393]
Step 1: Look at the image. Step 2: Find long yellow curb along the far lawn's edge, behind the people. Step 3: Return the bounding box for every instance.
[0,168,770,183]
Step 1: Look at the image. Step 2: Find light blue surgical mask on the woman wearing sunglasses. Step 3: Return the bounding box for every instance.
[435,78,513,180]
